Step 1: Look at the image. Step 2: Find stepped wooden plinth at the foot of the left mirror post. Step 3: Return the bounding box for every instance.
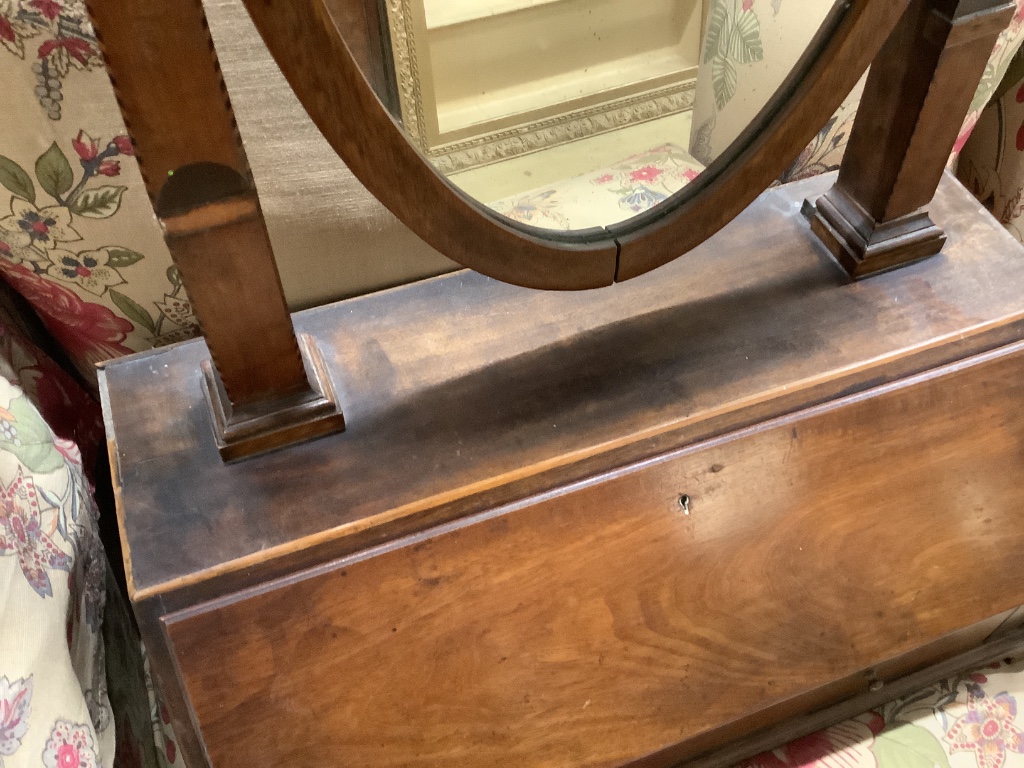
[202,334,345,462]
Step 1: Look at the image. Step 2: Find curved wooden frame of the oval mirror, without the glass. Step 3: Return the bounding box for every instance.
[246,0,909,289]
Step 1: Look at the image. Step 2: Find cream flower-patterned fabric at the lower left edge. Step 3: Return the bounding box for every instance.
[0,370,115,768]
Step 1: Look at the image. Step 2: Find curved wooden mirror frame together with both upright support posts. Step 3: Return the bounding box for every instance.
[87,0,1015,460]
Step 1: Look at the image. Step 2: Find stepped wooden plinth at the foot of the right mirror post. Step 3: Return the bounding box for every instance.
[803,187,946,280]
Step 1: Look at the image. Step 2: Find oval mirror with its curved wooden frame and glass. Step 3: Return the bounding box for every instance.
[237,0,908,289]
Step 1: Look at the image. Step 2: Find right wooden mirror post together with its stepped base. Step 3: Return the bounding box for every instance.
[805,0,1015,280]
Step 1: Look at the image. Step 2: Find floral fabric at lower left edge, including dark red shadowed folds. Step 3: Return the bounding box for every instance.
[0,313,180,768]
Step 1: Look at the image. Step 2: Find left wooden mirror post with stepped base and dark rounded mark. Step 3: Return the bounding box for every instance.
[87,0,344,461]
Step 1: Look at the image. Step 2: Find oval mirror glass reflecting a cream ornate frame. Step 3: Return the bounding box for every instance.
[344,0,842,231]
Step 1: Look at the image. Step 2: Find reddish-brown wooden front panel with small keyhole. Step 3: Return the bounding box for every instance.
[167,346,1024,768]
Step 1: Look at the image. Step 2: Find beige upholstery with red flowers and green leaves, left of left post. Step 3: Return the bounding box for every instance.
[0,0,198,387]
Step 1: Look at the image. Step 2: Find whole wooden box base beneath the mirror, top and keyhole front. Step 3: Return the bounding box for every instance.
[100,177,1024,768]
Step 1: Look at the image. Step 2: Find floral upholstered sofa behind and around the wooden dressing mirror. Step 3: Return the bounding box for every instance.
[0,0,1024,768]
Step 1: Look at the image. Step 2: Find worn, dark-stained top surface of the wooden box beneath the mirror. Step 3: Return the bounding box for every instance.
[100,175,1024,597]
